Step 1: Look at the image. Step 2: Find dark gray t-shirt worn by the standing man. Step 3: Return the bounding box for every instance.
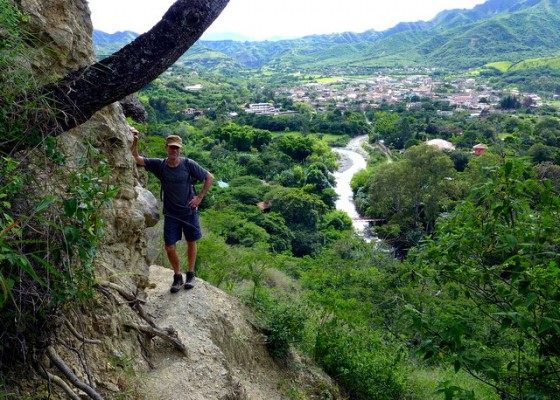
[144,157,208,217]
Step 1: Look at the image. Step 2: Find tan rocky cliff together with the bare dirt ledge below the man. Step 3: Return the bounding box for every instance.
[10,0,335,399]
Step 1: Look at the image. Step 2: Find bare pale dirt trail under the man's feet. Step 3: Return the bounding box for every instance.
[142,266,286,400]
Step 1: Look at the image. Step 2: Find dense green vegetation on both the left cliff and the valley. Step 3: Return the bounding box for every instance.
[0,1,560,399]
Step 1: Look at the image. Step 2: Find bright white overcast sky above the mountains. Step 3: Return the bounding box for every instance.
[88,0,485,40]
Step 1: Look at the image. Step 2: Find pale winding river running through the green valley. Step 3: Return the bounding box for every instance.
[333,135,374,242]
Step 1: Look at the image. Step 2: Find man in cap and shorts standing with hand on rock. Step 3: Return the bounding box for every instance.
[130,127,214,293]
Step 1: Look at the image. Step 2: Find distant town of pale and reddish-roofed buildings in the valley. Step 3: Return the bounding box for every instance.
[245,69,543,116]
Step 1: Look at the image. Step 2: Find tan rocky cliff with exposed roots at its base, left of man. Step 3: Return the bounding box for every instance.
[7,0,173,399]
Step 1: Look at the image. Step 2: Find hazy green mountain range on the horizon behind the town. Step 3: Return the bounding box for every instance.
[94,0,560,69]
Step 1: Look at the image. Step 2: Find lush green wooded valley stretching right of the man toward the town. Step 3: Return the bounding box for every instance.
[119,42,560,399]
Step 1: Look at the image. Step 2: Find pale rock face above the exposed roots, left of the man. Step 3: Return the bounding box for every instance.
[14,0,157,277]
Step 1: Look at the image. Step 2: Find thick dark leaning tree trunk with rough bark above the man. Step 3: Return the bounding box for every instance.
[40,0,229,135]
